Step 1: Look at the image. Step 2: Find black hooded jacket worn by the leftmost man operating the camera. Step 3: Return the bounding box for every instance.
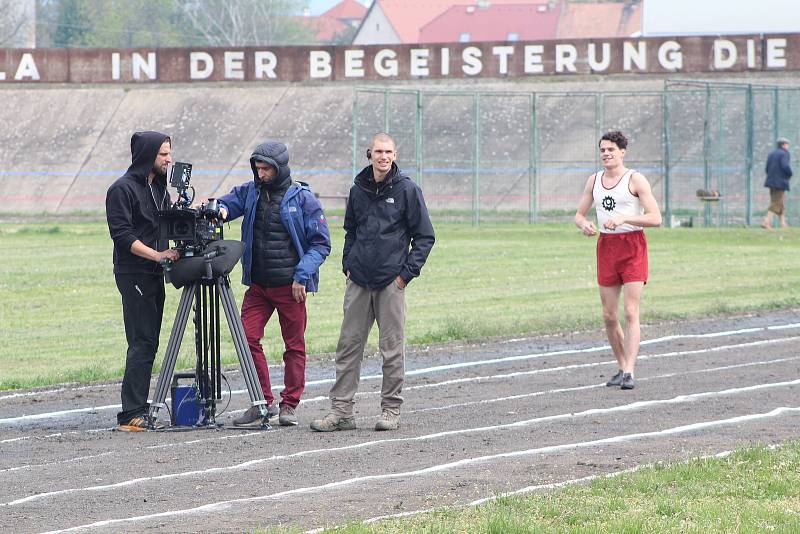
[106,132,170,274]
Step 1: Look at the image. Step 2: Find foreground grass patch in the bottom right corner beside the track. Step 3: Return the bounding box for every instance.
[300,441,800,534]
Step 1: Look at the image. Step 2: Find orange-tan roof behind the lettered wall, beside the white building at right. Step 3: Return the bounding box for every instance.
[558,2,642,39]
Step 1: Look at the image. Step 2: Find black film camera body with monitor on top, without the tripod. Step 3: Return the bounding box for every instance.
[158,162,222,257]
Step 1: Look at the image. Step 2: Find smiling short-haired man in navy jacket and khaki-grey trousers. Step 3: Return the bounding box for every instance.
[311,133,434,432]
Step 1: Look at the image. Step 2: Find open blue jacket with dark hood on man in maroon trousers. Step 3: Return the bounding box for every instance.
[218,142,331,293]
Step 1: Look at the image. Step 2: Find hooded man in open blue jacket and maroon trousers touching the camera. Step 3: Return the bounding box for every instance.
[219,141,331,426]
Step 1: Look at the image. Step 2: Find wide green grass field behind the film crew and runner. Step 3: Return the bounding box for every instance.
[0,220,800,389]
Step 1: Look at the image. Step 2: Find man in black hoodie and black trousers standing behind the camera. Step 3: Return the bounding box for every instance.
[106,132,178,432]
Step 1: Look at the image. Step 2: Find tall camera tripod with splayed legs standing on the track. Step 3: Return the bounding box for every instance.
[149,249,271,430]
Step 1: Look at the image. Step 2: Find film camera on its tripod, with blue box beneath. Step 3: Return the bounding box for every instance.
[149,162,270,430]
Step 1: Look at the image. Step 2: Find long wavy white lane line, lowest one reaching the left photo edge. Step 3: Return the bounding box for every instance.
[7,379,800,506]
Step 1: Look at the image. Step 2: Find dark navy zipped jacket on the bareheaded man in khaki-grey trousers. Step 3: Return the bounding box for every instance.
[342,163,435,289]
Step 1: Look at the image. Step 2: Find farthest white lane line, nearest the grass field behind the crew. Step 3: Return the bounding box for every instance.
[6,323,800,401]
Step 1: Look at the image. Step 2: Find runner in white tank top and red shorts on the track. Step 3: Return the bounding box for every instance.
[575,132,661,389]
